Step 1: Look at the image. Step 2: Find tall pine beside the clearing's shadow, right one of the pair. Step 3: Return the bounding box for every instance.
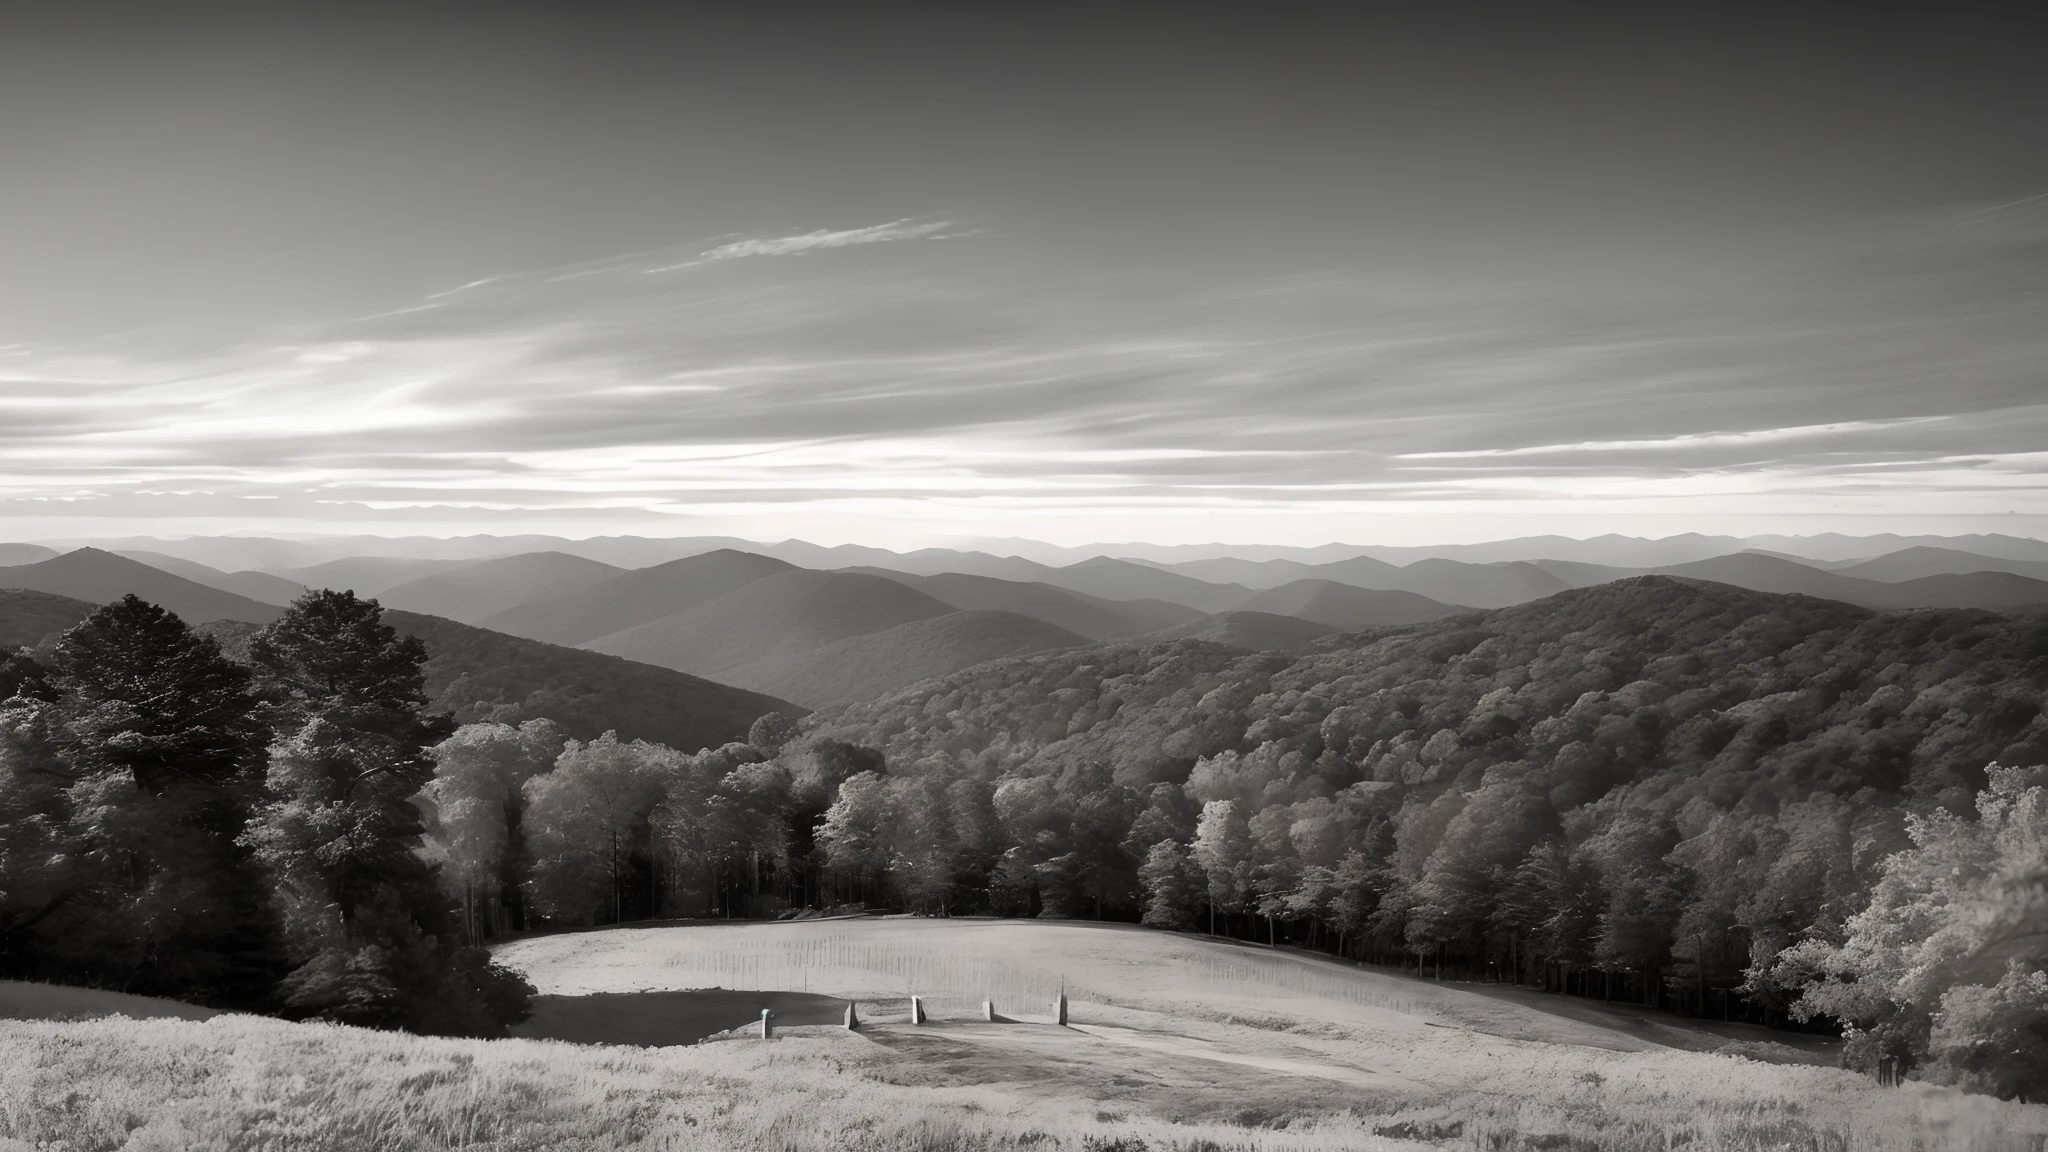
[244,590,524,1035]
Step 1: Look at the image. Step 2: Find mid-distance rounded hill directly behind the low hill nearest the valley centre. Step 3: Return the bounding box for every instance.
[584,553,954,685]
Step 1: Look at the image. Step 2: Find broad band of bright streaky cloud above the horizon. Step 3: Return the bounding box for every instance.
[0,196,2048,539]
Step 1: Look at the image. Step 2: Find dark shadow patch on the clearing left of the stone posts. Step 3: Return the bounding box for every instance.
[512,988,846,1047]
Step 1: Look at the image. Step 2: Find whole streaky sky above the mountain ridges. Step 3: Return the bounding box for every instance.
[0,4,2048,547]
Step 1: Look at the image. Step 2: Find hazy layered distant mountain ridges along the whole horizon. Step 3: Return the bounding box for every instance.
[0,537,2048,713]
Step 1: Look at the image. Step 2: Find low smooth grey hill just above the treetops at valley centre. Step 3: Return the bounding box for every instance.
[745,611,1087,707]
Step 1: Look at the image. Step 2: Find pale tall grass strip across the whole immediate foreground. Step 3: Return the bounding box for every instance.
[0,1017,2048,1152]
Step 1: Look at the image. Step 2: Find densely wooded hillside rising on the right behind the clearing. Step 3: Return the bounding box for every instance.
[786,578,2048,1065]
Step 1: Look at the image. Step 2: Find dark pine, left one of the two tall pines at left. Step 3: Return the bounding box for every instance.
[53,596,281,1006]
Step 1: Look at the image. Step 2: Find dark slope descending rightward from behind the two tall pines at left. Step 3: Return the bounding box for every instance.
[203,609,809,752]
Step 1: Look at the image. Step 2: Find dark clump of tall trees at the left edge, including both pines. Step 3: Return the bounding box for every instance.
[0,592,532,1035]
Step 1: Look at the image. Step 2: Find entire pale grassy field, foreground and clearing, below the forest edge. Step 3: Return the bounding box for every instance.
[0,920,2048,1152]
